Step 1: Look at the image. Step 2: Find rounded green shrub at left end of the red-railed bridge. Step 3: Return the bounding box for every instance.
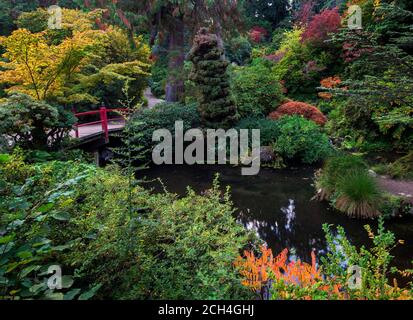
[0,93,76,150]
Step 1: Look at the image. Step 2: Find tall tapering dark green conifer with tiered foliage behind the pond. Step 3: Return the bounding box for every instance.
[189,28,237,128]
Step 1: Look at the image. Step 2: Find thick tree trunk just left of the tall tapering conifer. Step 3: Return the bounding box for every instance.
[165,18,185,102]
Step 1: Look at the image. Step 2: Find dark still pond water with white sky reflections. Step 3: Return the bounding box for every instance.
[139,165,413,269]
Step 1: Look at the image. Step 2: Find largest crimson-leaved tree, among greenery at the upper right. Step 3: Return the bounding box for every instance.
[302,8,341,44]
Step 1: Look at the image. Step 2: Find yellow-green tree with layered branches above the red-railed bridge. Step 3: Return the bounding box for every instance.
[66,27,151,107]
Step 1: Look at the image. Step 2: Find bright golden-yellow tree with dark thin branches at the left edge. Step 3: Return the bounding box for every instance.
[0,29,94,100]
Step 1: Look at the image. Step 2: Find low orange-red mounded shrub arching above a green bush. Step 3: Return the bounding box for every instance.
[269,101,327,126]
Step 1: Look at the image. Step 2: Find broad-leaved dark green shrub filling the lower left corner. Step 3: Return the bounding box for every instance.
[0,152,97,300]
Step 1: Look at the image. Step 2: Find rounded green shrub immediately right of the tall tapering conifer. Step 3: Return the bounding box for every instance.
[231,63,284,117]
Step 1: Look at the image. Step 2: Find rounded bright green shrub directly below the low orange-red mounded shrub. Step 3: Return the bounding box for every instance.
[274,116,332,164]
